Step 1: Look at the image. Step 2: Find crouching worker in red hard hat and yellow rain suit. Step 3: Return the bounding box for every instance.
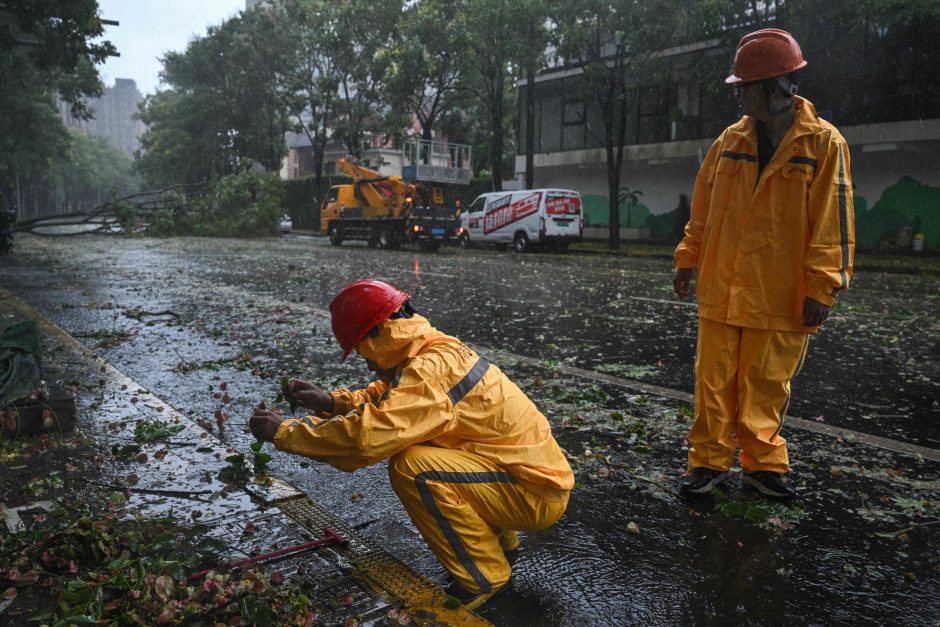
[249,280,574,609]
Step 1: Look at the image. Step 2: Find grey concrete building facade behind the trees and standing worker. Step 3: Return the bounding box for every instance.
[515,20,940,249]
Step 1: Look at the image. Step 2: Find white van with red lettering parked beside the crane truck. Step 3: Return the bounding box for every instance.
[460,189,584,253]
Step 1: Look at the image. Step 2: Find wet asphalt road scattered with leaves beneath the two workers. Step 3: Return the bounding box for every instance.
[0,237,940,625]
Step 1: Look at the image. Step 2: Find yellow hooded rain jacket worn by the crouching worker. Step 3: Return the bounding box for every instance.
[274,315,574,495]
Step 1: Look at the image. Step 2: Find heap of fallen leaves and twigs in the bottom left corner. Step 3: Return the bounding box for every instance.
[0,499,315,627]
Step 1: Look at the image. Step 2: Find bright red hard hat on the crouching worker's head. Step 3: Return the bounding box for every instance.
[330,279,408,361]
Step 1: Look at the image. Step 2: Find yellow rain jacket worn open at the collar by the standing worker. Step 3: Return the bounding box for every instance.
[675,97,855,333]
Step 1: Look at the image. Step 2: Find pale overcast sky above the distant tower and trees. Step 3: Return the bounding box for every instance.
[98,0,245,95]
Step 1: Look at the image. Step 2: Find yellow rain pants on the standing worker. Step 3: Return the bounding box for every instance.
[689,318,809,473]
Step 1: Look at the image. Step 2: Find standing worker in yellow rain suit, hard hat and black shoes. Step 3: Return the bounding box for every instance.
[673,29,855,497]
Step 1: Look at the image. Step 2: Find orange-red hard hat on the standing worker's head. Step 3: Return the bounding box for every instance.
[725,28,806,84]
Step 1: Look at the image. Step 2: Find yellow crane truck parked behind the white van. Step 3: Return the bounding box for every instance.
[320,159,463,250]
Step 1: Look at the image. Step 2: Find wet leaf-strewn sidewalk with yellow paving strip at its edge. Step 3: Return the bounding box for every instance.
[0,289,488,625]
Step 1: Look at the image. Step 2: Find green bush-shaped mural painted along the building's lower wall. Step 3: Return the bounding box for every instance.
[582,176,940,251]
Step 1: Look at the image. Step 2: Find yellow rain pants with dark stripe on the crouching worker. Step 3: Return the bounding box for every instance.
[388,445,568,593]
